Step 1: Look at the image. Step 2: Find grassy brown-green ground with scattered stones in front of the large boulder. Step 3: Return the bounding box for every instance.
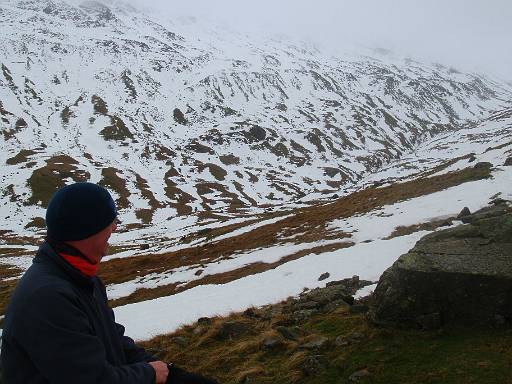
[146,294,512,384]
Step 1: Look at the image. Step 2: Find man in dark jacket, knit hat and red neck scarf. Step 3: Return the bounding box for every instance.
[0,183,215,384]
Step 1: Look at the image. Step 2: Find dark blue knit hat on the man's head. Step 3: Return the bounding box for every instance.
[46,183,117,241]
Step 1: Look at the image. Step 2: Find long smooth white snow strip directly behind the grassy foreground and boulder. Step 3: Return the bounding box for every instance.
[114,232,426,340]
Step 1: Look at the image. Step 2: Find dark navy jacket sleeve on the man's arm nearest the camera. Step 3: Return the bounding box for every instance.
[12,288,155,384]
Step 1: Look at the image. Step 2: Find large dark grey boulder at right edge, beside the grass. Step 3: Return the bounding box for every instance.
[370,202,512,329]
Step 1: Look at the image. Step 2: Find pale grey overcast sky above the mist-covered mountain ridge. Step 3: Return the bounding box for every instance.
[131,0,512,81]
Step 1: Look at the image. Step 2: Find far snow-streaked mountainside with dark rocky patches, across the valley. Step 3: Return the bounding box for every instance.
[0,0,512,237]
